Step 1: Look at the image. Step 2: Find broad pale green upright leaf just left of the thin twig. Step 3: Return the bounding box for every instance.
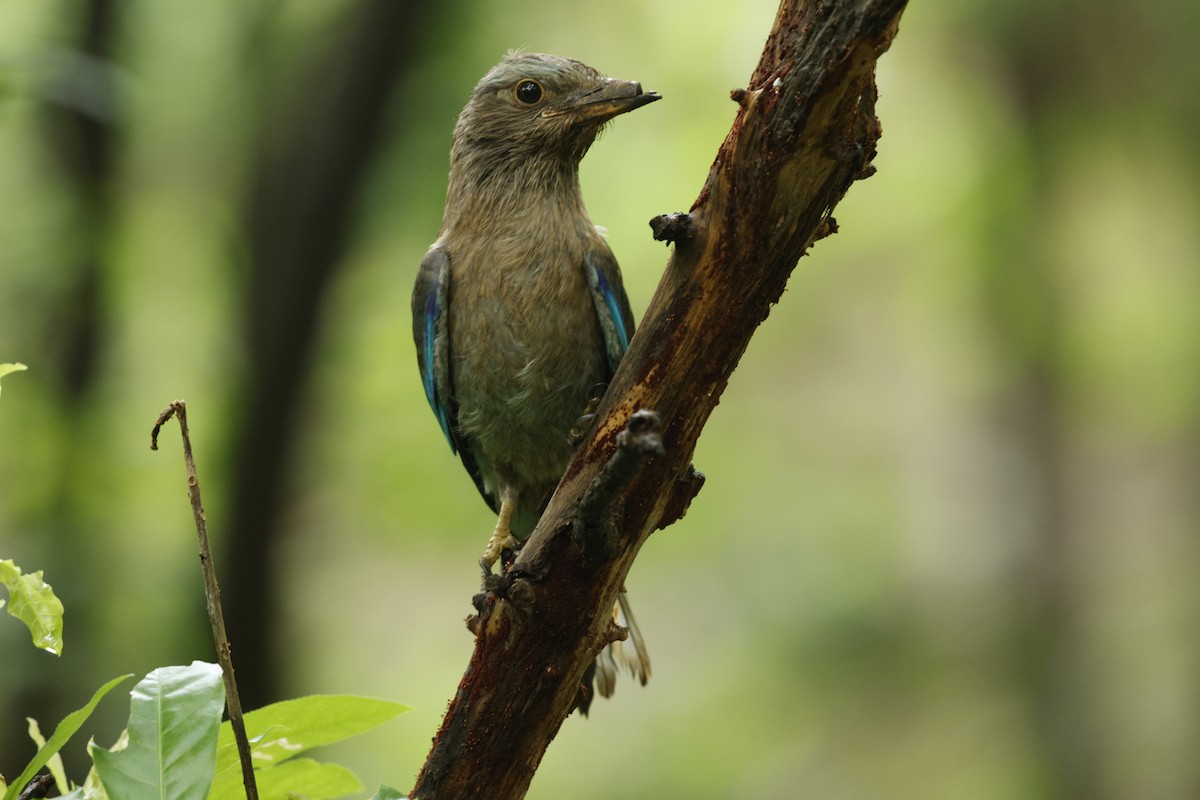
[91,661,224,800]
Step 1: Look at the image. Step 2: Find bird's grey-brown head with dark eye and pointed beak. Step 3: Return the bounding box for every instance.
[454,53,661,169]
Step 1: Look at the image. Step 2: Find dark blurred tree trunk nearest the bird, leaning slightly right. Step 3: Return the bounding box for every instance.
[221,0,430,709]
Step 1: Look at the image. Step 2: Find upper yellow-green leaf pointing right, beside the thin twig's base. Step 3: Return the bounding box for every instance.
[209,694,409,800]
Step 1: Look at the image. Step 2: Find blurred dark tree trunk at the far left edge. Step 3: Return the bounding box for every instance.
[0,0,121,767]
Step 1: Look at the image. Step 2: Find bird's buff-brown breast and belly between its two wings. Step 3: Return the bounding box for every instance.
[450,227,607,483]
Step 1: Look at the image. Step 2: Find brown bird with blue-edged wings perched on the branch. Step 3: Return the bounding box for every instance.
[412,52,661,712]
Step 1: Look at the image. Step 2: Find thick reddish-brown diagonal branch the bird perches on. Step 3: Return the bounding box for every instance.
[412,0,906,800]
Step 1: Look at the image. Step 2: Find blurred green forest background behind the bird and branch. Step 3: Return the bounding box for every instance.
[0,0,1200,799]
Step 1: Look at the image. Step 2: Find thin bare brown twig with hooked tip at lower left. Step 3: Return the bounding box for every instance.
[150,401,258,800]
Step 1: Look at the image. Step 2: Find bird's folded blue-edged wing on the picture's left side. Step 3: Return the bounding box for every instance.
[413,247,499,511]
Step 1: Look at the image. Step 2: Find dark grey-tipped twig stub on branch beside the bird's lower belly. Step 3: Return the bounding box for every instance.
[572,409,666,565]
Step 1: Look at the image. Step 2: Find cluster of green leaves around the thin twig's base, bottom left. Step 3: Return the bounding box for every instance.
[0,661,408,800]
